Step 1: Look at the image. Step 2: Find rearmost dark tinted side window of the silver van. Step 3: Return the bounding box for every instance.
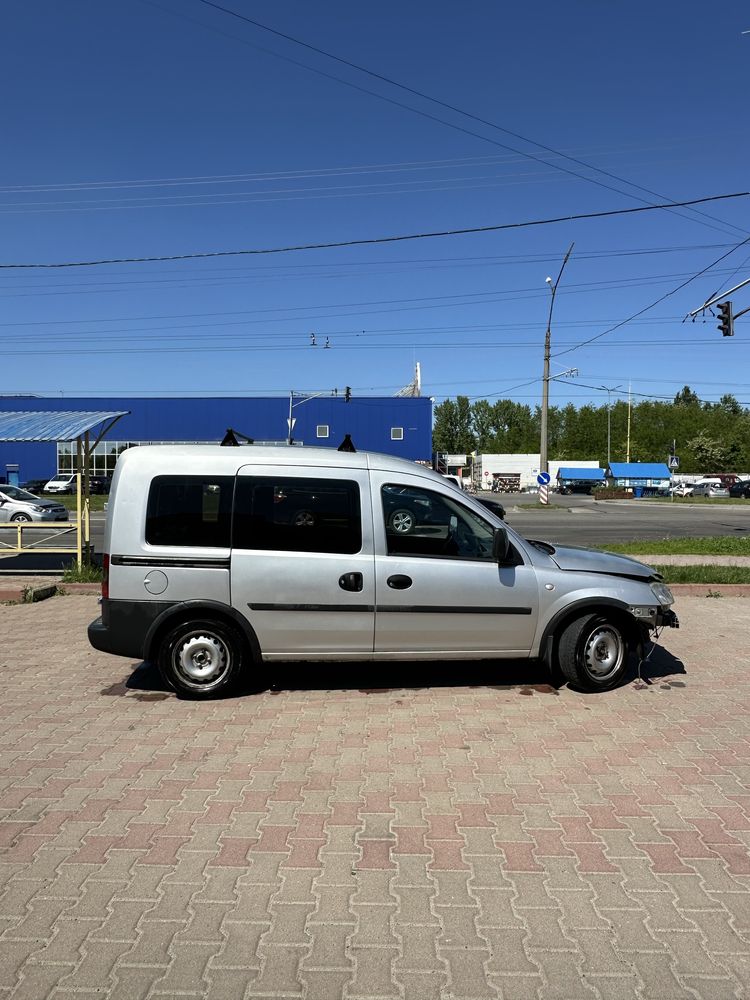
[146,476,234,548]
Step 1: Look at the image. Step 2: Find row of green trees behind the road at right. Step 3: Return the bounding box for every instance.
[433,386,750,474]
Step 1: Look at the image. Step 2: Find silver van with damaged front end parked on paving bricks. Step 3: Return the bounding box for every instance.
[88,445,678,697]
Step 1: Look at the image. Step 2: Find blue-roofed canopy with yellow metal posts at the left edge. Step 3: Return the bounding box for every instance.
[0,410,129,569]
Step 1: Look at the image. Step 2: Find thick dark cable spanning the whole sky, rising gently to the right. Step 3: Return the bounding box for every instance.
[0,191,750,270]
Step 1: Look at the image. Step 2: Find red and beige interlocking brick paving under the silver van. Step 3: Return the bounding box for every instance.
[0,596,750,1000]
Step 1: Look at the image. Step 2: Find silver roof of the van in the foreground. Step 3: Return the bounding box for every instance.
[117,444,443,480]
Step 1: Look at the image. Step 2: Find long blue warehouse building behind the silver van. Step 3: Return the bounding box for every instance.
[0,394,432,482]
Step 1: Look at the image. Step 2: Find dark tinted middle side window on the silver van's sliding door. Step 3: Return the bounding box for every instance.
[233,476,362,553]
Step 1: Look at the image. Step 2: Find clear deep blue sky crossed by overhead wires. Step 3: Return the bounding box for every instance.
[0,0,750,405]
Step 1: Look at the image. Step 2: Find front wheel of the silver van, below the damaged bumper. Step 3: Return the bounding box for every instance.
[557,614,630,691]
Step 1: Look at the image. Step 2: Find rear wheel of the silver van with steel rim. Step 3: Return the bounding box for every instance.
[158,619,247,698]
